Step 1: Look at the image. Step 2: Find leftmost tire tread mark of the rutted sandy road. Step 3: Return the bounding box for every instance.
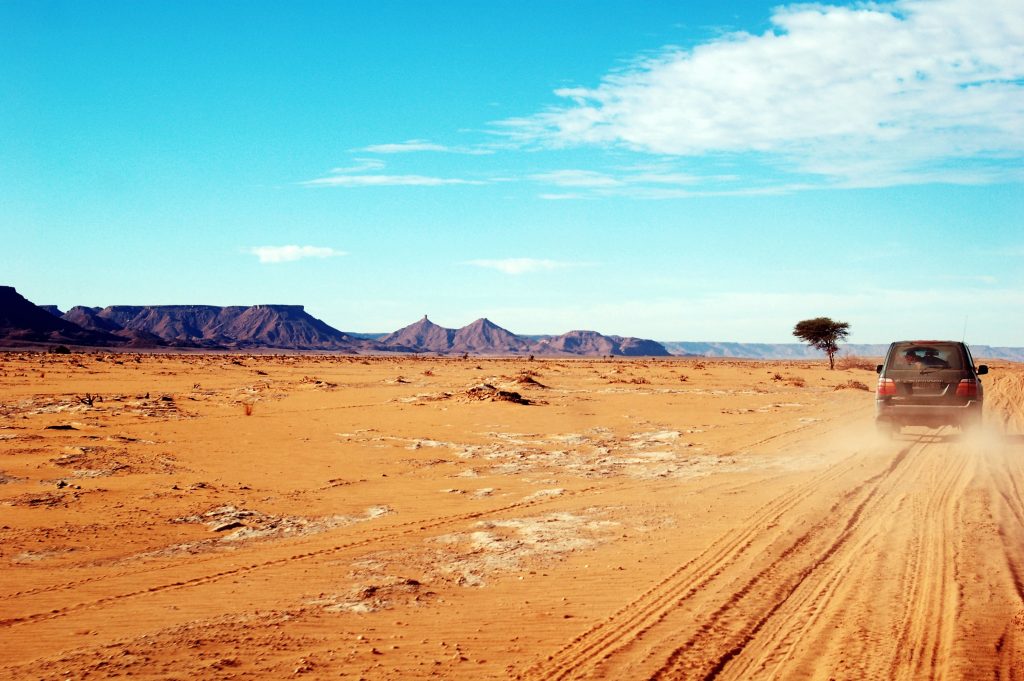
[524,446,880,679]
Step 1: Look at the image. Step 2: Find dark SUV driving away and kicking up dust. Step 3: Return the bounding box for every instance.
[874,341,988,435]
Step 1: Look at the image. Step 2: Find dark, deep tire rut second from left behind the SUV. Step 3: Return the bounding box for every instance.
[651,444,916,680]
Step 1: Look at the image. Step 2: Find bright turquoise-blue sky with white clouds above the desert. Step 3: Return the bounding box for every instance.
[0,0,1024,339]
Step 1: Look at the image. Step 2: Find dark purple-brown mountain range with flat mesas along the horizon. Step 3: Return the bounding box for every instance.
[0,286,1024,361]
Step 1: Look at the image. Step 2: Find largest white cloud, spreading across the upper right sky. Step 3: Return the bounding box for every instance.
[504,0,1024,186]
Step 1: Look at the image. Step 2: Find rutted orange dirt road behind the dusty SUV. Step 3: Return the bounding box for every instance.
[527,430,1024,679]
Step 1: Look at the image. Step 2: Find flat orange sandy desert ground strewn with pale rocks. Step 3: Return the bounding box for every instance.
[0,353,1024,679]
